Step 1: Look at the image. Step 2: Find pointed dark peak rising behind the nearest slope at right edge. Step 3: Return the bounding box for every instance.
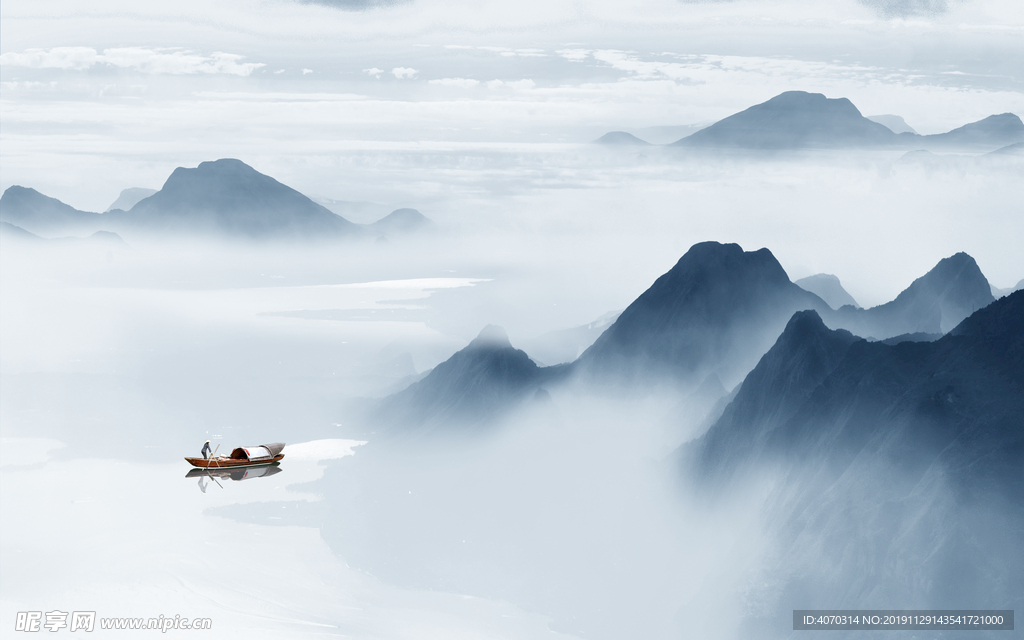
[825,253,994,340]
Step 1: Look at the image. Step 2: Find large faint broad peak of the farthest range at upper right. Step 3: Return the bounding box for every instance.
[674,91,898,150]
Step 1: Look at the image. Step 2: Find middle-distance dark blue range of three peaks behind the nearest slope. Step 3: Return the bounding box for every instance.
[382,242,993,432]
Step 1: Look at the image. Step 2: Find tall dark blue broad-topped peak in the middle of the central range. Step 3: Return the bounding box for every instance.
[575,242,830,388]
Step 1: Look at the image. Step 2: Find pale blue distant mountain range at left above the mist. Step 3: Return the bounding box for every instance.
[0,159,430,240]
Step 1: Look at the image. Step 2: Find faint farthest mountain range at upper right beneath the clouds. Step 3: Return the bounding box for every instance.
[598,91,1024,151]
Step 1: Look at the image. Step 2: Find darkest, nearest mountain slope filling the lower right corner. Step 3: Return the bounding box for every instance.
[681,292,1024,637]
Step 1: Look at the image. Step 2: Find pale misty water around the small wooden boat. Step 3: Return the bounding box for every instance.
[0,145,1024,638]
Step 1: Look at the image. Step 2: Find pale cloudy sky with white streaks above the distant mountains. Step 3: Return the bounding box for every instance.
[0,0,1024,210]
